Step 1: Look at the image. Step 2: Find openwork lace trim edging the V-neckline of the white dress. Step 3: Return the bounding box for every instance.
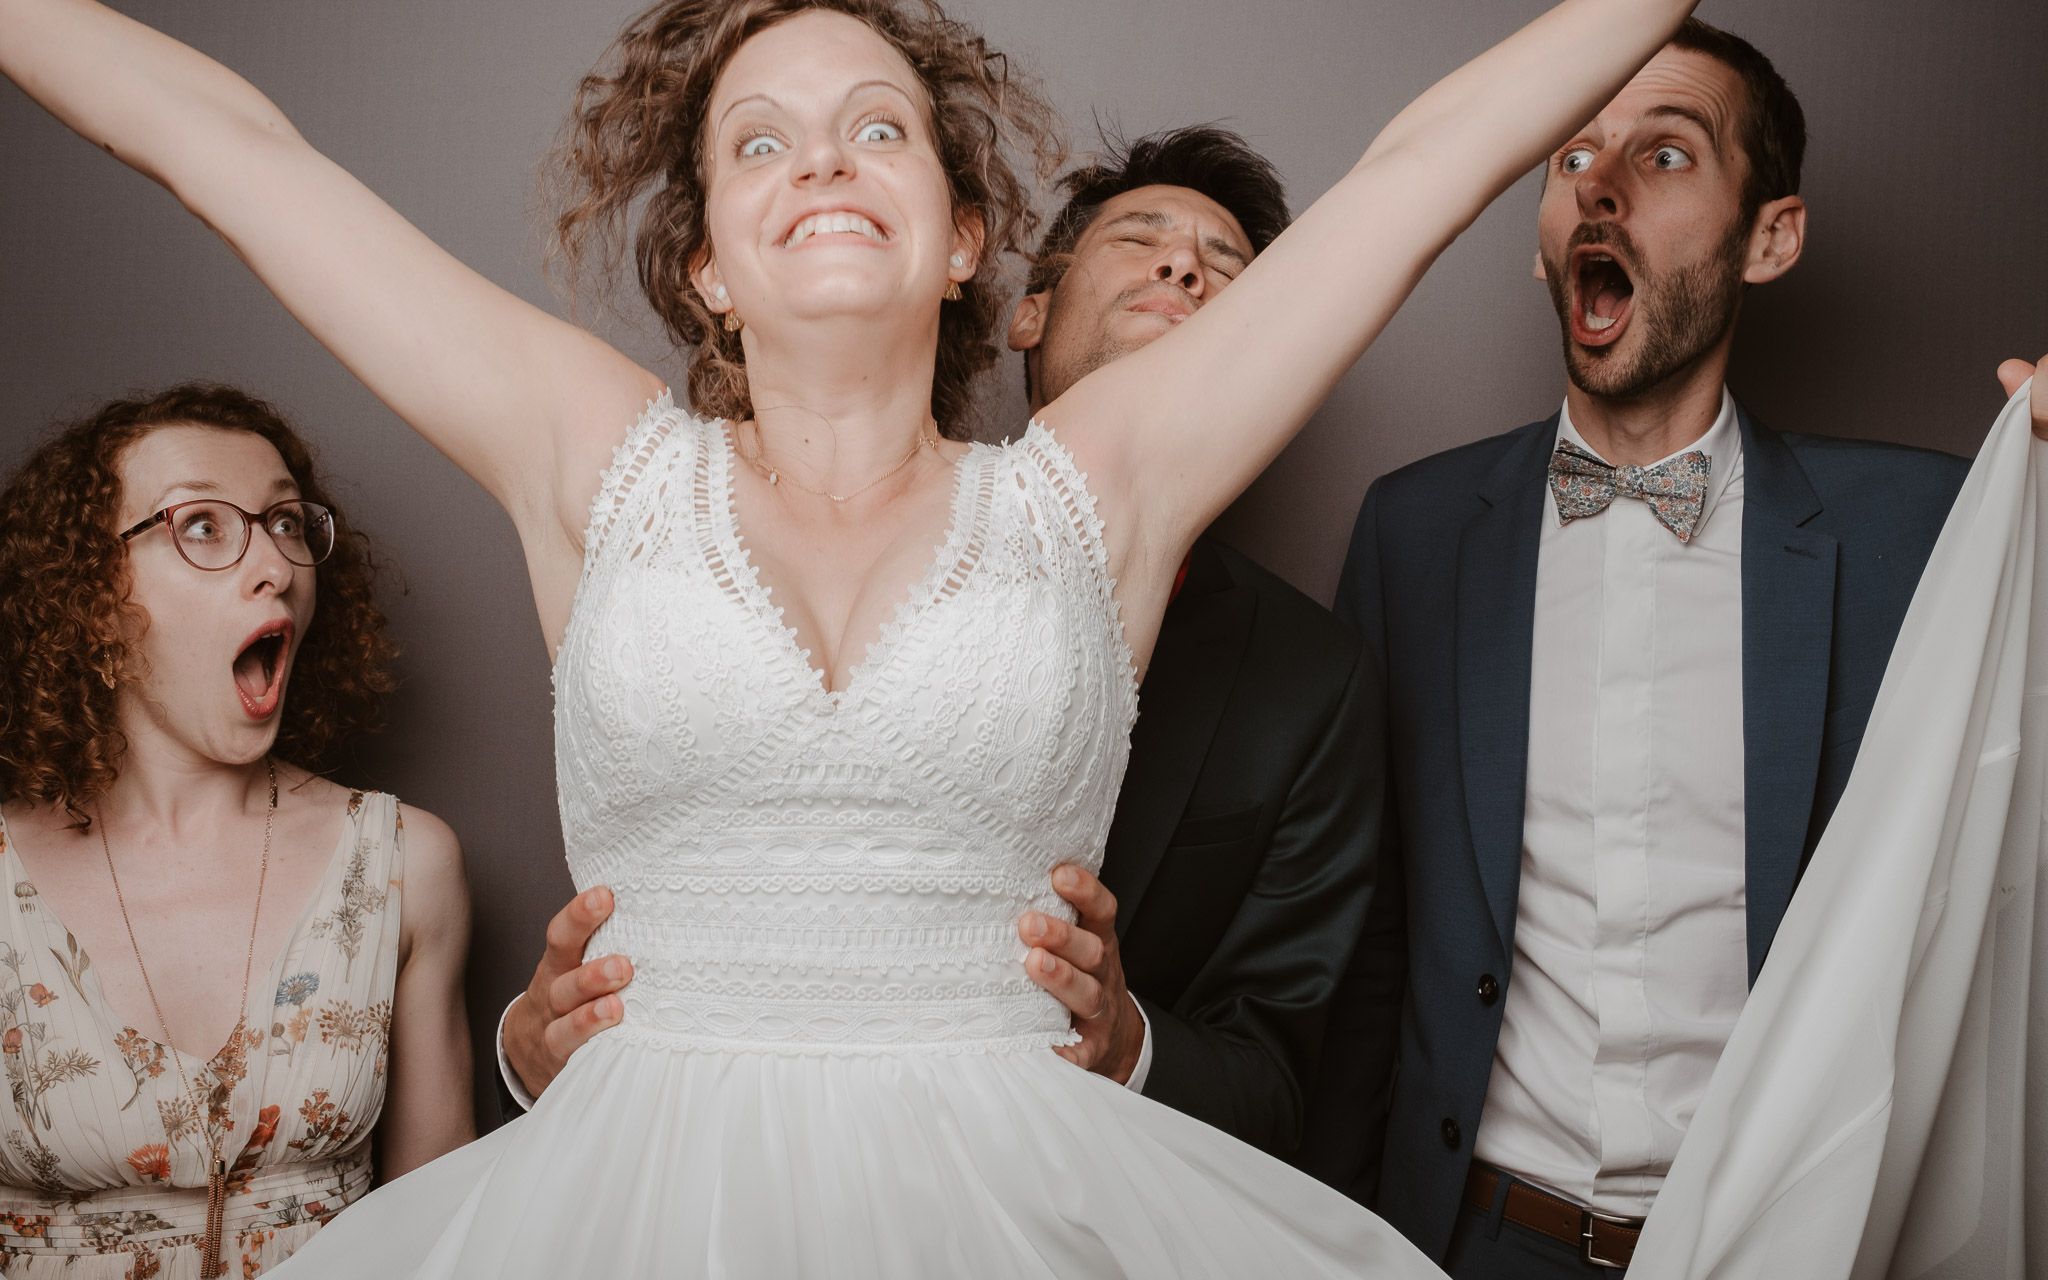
[705,420,987,711]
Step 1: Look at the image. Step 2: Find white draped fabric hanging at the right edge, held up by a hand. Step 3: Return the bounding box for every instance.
[1630,387,2048,1280]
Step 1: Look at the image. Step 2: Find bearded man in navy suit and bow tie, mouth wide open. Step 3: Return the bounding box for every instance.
[1300,20,2017,1280]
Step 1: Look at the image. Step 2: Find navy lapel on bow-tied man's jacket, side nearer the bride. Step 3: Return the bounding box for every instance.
[1456,416,1556,950]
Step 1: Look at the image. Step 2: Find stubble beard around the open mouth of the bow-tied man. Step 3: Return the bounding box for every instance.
[1544,219,1749,399]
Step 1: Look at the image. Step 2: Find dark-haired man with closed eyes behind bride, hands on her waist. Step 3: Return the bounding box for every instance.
[500,127,1382,1151]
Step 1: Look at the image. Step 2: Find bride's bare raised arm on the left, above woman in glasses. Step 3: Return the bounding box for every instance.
[0,0,662,633]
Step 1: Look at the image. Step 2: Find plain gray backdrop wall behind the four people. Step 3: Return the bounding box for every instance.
[0,0,2048,1110]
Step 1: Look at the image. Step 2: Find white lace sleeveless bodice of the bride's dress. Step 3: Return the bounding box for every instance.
[555,395,1137,1053]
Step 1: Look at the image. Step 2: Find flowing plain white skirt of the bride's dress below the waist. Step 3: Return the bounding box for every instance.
[274,1032,1442,1280]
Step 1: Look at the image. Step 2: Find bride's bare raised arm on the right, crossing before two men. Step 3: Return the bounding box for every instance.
[1042,0,1692,585]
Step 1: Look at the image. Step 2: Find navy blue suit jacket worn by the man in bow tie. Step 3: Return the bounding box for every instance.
[1296,412,1968,1260]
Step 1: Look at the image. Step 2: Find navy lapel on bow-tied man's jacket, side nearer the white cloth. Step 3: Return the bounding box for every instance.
[1737,406,1837,983]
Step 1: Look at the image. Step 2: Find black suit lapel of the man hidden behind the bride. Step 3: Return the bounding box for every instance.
[1102,539,1257,936]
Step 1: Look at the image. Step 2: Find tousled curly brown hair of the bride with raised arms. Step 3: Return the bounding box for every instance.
[551,0,1065,440]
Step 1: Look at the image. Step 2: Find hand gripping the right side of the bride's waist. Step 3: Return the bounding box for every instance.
[1018,864,1145,1083]
